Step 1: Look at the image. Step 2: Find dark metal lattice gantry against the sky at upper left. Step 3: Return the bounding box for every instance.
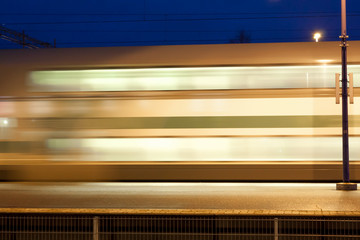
[0,26,55,49]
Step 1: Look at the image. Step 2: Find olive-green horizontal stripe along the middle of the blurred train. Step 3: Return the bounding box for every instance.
[18,115,360,130]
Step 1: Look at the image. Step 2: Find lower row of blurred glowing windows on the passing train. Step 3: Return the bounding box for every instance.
[43,137,360,162]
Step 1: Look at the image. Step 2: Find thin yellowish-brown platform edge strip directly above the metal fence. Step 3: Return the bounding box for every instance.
[0,208,360,217]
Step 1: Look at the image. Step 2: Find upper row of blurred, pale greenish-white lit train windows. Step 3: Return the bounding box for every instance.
[30,65,360,92]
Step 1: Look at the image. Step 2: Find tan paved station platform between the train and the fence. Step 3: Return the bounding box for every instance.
[0,182,360,216]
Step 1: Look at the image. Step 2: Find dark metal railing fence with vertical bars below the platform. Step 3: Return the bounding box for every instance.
[0,215,360,240]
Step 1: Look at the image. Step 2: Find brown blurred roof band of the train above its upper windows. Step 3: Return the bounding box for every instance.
[0,41,360,66]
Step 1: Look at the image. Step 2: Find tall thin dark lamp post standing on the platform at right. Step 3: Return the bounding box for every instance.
[336,0,357,190]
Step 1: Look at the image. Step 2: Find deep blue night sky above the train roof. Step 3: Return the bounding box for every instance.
[0,0,360,48]
